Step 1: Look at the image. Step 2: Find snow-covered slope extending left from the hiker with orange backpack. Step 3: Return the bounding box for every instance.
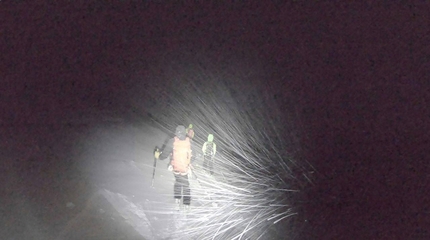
[0,113,288,240]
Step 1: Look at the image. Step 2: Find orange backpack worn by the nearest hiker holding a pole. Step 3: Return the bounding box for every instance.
[171,137,191,173]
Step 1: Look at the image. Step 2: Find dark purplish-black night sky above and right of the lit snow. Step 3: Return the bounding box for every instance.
[0,1,430,239]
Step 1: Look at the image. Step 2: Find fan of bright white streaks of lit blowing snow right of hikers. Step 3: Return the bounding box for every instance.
[124,60,310,239]
